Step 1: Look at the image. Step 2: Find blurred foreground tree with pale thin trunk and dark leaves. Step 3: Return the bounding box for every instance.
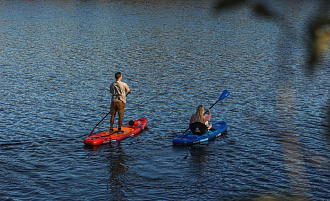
[214,0,330,200]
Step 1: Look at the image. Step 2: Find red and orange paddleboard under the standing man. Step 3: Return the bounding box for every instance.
[84,117,147,146]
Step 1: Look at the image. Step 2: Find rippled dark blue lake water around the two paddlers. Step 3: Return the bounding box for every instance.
[0,0,330,200]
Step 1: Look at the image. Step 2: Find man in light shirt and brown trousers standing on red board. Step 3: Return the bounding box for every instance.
[109,72,132,133]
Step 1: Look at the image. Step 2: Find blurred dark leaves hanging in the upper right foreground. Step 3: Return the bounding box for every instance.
[214,0,330,133]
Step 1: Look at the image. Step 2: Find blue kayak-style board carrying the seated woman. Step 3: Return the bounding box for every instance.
[172,121,227,146]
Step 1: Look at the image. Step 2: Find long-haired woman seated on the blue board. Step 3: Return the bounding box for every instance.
[189,105,212,135]
